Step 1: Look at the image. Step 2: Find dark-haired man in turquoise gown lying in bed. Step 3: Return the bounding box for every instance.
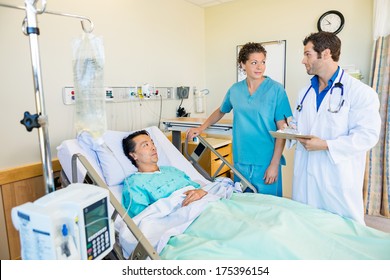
[122,130,207,217]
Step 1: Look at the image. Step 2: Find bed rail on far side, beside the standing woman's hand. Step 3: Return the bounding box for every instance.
[183,136,257,193]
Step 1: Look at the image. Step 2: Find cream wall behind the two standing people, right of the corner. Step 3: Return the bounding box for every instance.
[205,0,373,197]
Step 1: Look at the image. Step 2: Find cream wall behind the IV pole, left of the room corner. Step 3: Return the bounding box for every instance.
[0,0,205,170]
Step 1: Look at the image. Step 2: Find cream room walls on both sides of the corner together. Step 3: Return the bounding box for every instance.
[0,0,373,196]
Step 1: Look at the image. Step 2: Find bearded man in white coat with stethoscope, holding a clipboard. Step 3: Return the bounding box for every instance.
[292,32,381,224]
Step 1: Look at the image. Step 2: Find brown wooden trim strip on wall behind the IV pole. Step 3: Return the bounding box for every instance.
[0,159,61,186]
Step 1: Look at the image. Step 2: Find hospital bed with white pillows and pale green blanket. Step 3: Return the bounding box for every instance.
[57,127,390,260]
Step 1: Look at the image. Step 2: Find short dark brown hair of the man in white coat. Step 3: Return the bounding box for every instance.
[303,31,341,62]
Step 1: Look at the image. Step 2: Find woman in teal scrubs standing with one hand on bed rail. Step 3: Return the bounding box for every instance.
[187,43,292,196]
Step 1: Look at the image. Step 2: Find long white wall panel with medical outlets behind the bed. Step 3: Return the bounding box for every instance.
[62,84,175,105]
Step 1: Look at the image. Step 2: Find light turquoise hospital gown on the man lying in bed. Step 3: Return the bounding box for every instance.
[122,166,200,217]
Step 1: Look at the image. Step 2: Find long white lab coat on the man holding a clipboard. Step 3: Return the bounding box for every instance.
[292,70,381,224]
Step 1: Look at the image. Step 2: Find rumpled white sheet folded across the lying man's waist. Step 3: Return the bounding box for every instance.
[116,178,241,258]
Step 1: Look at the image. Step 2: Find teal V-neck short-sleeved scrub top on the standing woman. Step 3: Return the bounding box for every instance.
[220,77,292,166]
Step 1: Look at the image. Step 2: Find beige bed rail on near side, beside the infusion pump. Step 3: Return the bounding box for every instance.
[72,154,160,260]
